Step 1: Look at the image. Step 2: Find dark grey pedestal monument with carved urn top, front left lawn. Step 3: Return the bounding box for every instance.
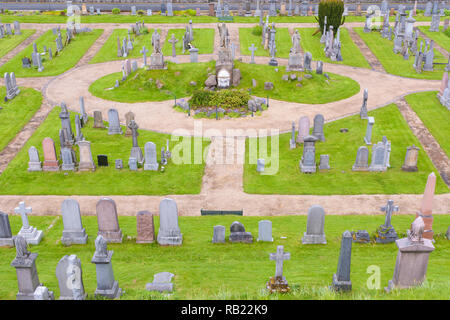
[91,235,122,299]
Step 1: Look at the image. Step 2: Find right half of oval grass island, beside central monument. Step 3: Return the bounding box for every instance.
[235,61,359,104]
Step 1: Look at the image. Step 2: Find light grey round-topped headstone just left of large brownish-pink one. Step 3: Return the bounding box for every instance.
[61,199,88,246]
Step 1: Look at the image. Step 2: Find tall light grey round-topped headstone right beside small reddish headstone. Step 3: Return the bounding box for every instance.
[157,198,183,246]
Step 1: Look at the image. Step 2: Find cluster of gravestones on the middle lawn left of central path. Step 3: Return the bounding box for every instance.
[28,97,171,172]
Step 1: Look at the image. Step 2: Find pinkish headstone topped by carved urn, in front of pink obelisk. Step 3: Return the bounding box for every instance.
[385,217,434,292]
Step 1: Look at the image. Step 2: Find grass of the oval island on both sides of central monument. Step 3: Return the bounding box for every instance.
[89,61,359,103]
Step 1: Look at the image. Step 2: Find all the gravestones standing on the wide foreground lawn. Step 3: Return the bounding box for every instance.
[0,173,442,300]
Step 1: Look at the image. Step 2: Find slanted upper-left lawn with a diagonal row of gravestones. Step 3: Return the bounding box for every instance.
[0,29,103,78]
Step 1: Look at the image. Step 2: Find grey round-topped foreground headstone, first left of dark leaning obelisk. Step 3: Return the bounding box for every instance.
[302,205,327,244]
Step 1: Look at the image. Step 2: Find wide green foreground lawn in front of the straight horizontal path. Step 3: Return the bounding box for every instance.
[0,212,450,300]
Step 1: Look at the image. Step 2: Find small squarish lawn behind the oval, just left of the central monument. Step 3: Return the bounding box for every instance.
[163,25,215,57]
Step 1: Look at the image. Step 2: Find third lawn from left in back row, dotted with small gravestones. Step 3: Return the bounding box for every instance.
[89,29,154,63]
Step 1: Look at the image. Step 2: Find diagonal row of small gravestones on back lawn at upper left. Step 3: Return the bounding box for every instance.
[22,24,92,72]
